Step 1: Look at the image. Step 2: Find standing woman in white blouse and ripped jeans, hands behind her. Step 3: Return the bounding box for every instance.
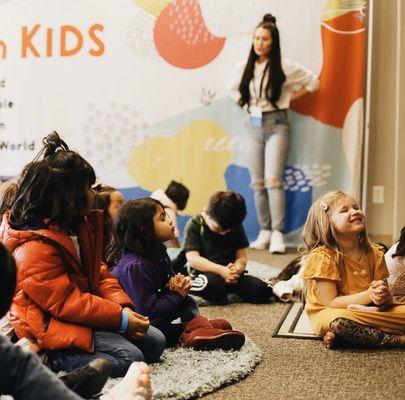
[231,14,319,253]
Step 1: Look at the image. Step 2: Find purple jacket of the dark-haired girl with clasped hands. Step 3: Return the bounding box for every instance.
[112,253,184,320]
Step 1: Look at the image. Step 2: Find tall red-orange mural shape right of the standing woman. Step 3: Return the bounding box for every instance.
[291,12,365,128]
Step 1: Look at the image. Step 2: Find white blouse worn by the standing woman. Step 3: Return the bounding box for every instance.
[228,58,319,112]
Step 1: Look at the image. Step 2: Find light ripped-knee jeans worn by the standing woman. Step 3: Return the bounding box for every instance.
[244,110,291,232]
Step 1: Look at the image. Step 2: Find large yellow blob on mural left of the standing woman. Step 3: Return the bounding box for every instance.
[127,119,232,214]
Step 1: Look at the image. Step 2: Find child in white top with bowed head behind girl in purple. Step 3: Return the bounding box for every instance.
[150,181,190,247]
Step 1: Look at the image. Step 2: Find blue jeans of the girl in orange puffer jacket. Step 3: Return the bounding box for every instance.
[48,326,166,378]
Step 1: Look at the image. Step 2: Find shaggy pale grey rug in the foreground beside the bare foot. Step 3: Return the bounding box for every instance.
[105,338,262,400]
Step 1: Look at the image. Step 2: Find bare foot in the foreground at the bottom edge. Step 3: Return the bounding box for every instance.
[101,362,153,400]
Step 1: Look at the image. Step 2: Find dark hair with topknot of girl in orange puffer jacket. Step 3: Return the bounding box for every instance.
[10,132,96,231]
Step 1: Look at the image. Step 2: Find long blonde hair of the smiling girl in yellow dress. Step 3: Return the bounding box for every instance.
[300,190,372,272]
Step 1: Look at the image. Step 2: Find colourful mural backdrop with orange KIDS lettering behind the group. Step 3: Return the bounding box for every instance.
[0,0,365,243]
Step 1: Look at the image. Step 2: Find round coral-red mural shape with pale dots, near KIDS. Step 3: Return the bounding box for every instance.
[154,0,225,69]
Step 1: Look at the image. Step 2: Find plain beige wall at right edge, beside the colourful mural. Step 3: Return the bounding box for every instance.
[366,0,405,244]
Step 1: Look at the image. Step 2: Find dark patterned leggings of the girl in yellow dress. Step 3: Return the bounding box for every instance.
[329,318,400,347]
